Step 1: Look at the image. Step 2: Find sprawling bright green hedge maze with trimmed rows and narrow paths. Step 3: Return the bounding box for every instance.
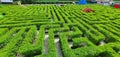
[0,4,120,57]
